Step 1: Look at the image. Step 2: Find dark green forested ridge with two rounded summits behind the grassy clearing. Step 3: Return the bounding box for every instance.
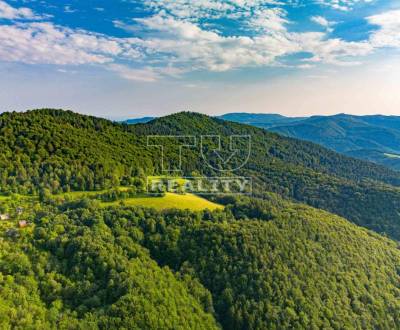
[0,110,400,239]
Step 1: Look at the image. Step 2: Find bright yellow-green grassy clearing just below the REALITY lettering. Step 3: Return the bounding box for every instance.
[101,193,224,211]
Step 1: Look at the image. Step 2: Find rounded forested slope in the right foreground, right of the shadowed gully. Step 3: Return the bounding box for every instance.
[145,195,400,329]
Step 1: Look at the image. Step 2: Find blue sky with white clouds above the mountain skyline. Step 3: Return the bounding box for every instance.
[0,0,400,119]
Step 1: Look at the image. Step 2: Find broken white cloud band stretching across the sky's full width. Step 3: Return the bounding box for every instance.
[0,0,400,82]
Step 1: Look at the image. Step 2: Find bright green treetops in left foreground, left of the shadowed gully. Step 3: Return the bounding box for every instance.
[0,208,217,330]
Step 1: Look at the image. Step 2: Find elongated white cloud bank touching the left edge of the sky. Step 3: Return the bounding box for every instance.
[0,22,139,65]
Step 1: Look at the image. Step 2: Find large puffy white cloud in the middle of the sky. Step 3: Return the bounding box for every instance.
[133,14,300,71]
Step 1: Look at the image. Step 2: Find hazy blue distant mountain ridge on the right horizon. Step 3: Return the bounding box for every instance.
[220,113,400,170]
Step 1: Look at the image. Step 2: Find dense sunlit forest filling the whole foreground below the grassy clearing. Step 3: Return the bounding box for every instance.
[0,195,400,329]
